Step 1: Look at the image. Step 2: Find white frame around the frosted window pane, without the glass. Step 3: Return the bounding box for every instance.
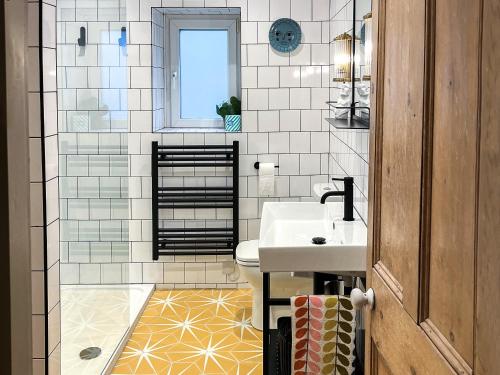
[165,15,241,128]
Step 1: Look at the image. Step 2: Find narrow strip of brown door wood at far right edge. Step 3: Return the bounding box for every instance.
[474,0,500,375]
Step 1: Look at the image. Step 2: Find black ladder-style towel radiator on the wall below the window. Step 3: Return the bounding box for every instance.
[151,141,239,260]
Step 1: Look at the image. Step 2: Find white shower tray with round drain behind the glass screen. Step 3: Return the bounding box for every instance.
[61,284,153,375]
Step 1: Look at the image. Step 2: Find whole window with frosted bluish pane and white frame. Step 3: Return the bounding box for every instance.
[165,15,240,128]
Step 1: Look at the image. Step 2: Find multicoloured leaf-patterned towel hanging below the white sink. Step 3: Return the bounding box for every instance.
[291,296,356,375]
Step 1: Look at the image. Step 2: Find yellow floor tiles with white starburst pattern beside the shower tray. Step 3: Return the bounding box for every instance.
[112,289,262,375]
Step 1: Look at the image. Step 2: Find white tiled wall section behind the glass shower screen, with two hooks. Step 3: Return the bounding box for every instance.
[57,0,132,284]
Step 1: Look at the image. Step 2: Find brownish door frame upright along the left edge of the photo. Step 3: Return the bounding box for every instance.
[0,0,33,375]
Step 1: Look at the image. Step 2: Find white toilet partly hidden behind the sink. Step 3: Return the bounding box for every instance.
[236,240,312,330]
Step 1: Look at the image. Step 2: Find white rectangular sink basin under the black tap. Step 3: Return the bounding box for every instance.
[259,202,367,274]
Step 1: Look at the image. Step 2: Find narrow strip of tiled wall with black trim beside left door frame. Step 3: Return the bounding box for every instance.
[26,0,61,374]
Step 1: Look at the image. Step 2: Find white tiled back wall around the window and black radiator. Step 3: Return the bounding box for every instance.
[57,0,331,287]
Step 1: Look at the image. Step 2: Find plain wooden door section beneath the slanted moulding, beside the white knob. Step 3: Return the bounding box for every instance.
[370,271,454,375]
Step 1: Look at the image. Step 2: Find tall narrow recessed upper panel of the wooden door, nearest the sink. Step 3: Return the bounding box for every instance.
[374,0,425,319]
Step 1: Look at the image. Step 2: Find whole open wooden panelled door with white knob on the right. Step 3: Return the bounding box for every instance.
[365,0,500,375]
